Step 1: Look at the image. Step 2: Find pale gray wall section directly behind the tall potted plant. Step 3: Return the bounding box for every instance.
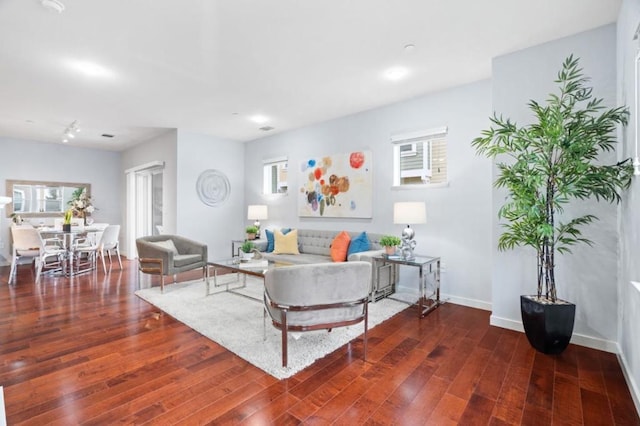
[491,25,618,351]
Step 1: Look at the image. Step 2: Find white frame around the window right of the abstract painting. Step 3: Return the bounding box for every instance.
[391,126,448,188]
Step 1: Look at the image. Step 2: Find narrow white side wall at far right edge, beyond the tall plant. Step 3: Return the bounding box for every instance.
[617,0,640,410]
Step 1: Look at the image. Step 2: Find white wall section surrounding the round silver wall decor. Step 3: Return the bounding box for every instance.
[176,130,247,260]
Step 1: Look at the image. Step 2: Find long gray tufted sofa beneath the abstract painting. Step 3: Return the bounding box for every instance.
[256,229,398,300]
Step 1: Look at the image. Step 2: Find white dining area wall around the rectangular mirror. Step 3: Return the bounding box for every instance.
[0,138,122,259]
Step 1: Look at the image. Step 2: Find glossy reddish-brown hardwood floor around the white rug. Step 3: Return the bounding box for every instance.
[0,261,640,425]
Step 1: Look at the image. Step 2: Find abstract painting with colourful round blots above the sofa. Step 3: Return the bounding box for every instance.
[298,151,373,218]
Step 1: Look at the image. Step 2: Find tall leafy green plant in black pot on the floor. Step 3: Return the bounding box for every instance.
[472,56,633,353]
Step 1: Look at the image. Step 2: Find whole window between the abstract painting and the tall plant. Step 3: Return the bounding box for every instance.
[391,127,447,186]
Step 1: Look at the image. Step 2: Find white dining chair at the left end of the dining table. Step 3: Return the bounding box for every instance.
[9,226,66,282]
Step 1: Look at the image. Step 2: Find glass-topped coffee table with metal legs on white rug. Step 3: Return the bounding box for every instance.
[206,257,293,302]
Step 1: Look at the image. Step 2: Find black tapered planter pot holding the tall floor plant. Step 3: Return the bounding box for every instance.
[520,296,576,354]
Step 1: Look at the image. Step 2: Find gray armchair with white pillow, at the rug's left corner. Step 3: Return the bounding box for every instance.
[136,234,208,292]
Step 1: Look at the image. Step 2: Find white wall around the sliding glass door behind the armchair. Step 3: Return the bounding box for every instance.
[119,129,178,258]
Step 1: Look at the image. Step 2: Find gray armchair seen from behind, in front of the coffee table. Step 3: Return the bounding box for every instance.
[264,261,371,367]
